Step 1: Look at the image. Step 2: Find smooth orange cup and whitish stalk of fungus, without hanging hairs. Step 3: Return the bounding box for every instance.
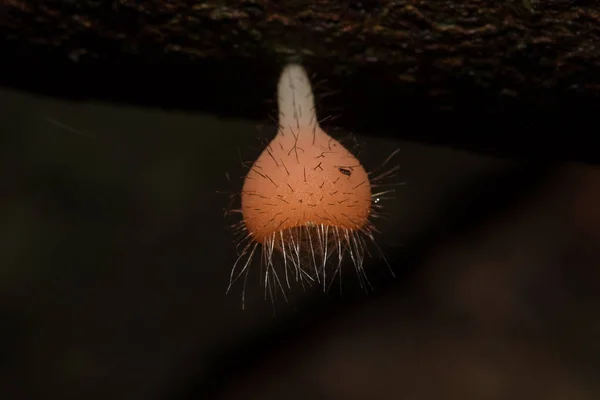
[241,65,371,242]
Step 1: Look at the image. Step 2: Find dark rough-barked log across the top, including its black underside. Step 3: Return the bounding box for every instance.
[0,0,600,160]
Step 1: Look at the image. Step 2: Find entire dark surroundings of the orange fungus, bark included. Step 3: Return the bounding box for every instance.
[0,0,600,400]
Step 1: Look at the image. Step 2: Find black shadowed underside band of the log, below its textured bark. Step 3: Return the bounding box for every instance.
[0,51,600,163]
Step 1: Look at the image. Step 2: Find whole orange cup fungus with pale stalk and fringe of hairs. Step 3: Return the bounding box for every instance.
[227,64,396,308]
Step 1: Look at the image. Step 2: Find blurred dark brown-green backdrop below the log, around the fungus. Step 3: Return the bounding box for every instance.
[0,81,600,400]
